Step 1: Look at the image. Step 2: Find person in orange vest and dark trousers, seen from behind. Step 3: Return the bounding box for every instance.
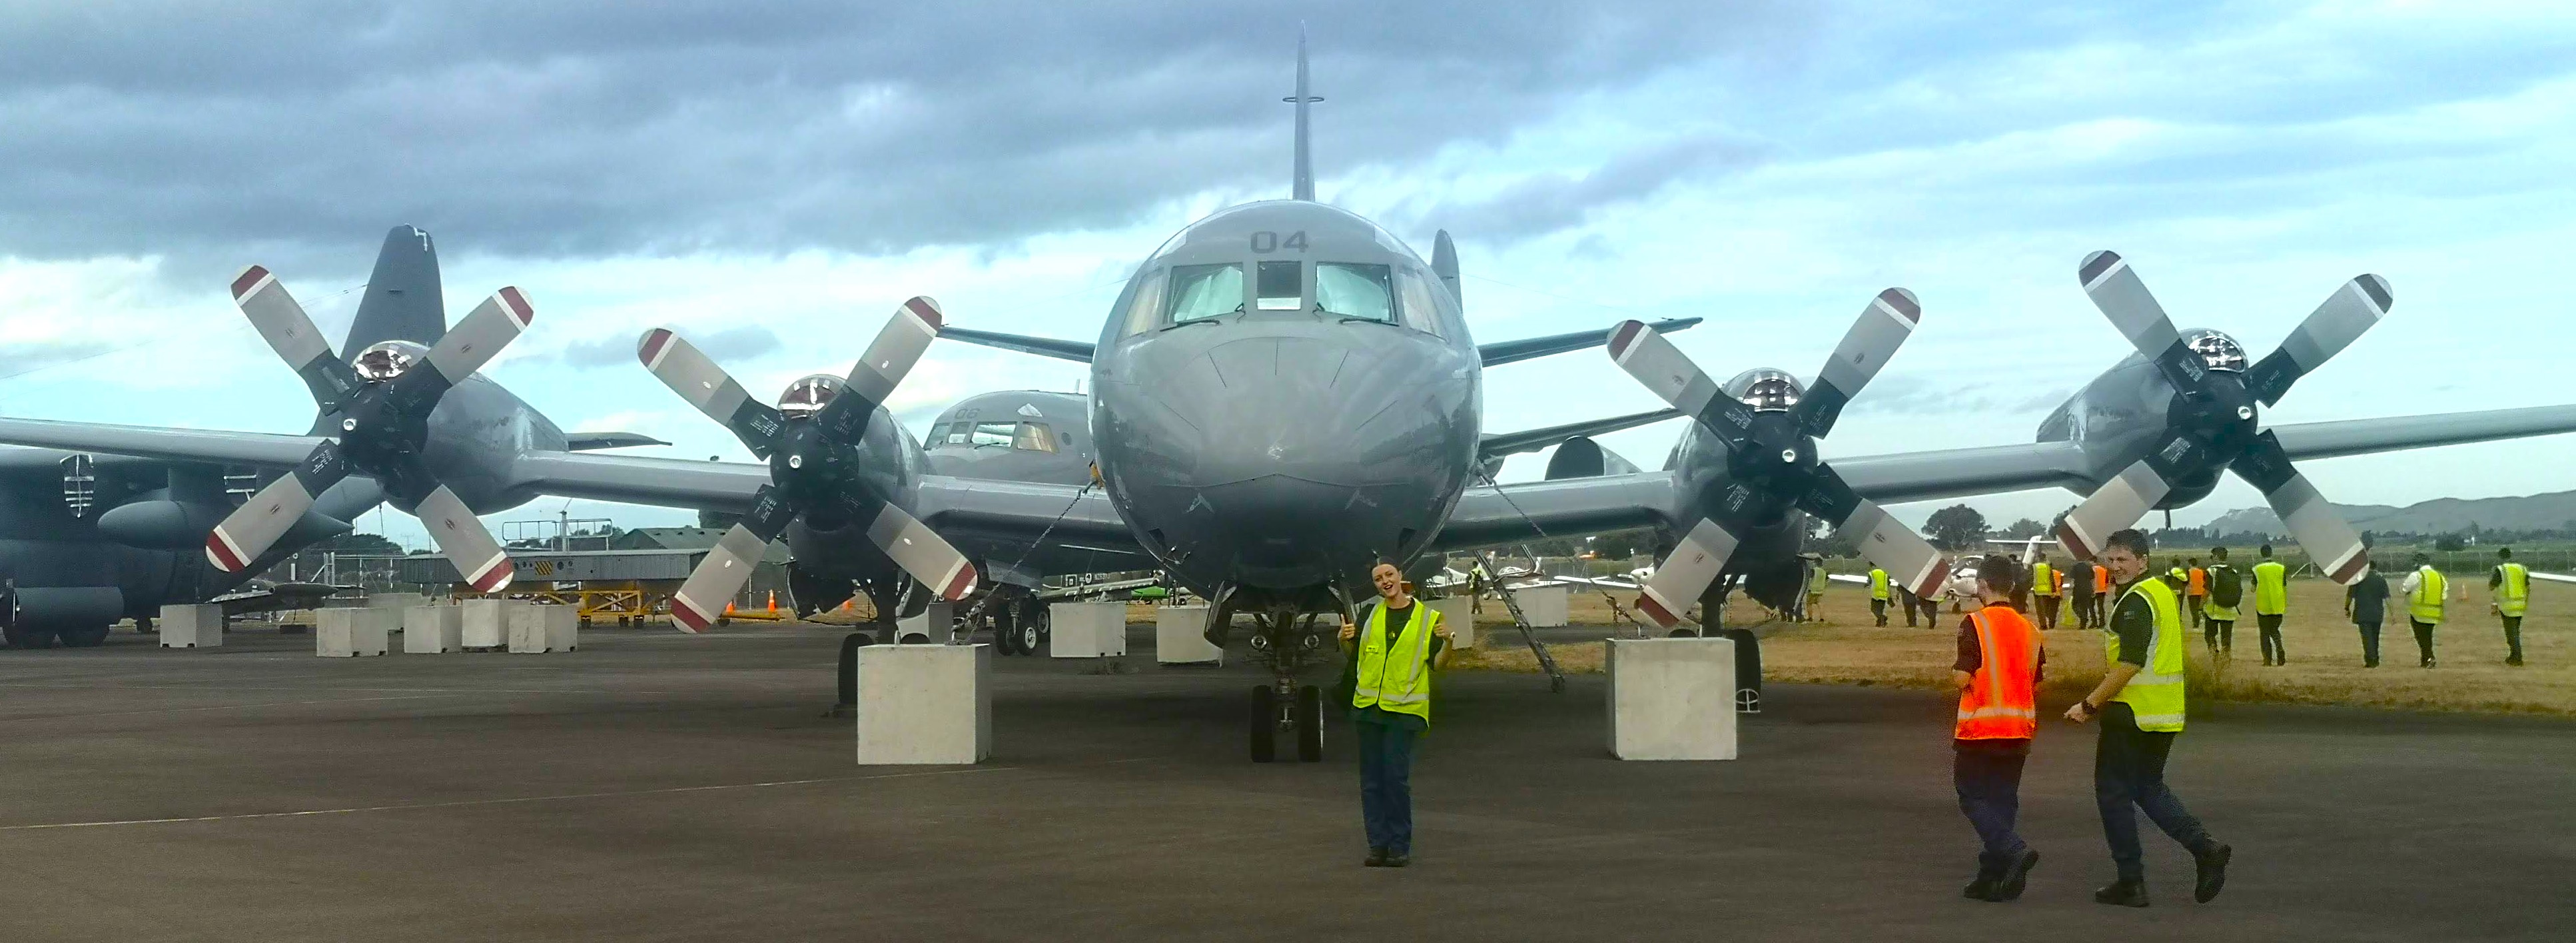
[1950,554,2048,902]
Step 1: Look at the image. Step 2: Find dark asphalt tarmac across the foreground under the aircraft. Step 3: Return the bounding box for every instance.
[0,626,2576,943]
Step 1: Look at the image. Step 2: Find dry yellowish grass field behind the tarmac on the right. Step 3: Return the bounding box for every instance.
[1450,577,2576,716]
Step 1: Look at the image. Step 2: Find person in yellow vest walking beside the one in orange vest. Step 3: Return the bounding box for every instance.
[2066,528,2236,907]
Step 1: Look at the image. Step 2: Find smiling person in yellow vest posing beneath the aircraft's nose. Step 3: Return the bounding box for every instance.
[1342,564,1450,868]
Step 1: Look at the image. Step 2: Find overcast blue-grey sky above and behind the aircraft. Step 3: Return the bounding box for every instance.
[0,0,2576,544]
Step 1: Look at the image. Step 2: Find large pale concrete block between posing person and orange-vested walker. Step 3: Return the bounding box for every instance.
[1602,639,1736,760]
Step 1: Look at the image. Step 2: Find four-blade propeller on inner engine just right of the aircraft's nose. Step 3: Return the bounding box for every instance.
[1610,289,1950,628]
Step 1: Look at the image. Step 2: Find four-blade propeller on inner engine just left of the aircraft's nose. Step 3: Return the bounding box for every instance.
[636,297,977,631]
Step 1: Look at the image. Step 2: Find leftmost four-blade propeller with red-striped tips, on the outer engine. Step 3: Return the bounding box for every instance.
[206,265,536,592]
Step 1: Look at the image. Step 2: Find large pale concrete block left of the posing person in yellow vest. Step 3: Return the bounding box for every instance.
[858,644,992,765]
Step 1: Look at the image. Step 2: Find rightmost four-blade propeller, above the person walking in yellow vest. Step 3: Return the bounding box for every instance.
[2058,253,2393,585]
